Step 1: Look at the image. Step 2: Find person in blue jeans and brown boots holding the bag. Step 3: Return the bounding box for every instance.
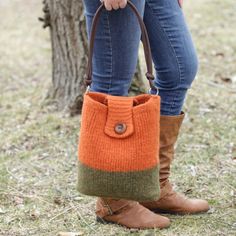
[84,0,209,228]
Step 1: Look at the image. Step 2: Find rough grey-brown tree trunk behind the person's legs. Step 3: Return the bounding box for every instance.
[40,0,145,115]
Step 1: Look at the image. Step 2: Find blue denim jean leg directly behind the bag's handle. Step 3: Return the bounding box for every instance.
[84,0,145,96]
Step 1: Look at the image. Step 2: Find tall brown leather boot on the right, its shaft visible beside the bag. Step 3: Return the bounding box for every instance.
[142,113,209,214]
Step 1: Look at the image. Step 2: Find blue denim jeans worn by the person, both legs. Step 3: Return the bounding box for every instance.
[83,0,198,115]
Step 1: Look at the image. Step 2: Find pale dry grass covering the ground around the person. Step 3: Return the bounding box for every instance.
[0,0,236,236]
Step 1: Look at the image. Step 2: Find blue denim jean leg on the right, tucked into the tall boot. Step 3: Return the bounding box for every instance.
[144,0,198,115]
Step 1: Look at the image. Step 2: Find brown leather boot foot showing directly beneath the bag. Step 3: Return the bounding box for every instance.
[96,198,170,229]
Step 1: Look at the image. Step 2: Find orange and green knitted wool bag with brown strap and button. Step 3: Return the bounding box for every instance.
[78,1,160,201]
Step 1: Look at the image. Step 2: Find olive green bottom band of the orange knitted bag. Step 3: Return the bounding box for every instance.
[77,162,160,202]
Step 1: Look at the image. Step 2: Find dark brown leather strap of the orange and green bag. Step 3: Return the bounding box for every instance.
[85,0,158,91]
